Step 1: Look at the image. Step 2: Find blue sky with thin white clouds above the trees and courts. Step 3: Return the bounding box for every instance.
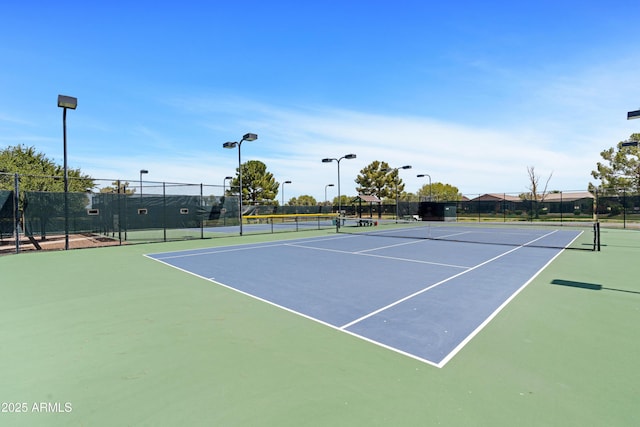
[0,0,640,201]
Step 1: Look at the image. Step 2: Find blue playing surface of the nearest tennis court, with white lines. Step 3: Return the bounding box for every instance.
[148,226,579,367]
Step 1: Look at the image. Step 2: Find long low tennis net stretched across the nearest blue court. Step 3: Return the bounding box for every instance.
[336,218,600,251]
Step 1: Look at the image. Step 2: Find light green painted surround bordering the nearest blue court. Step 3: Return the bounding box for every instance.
[0,229,640,427]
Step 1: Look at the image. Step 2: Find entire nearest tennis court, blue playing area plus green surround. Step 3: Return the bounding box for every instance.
[0,224,640,427]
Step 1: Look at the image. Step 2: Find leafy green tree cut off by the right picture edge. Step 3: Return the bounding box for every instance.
[589,133,640,194]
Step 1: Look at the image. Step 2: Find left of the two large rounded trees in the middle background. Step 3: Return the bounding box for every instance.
[226,160,280,204]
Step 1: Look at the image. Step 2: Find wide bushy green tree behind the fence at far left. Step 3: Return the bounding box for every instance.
[0,145,95,193]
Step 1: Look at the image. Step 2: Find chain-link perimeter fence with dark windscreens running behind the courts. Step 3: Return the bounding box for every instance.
[0,173,640,254]
